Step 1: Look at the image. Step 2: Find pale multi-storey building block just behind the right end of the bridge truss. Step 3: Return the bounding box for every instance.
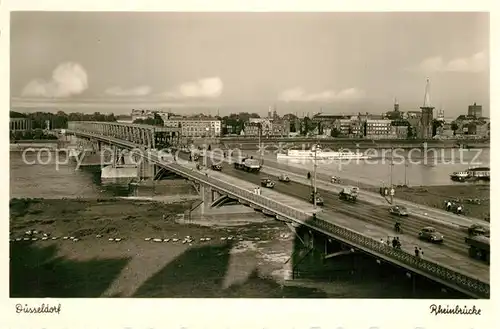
[163,116,221,138]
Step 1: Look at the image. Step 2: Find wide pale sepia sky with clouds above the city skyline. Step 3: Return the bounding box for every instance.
[10,12,489,117]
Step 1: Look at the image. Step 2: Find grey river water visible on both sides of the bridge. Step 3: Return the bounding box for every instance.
[10,149,490,198]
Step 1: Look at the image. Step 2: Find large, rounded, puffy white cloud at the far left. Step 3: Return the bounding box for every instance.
[21,62,89,98]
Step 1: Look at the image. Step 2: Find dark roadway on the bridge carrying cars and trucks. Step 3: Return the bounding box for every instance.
[180,154,489,280]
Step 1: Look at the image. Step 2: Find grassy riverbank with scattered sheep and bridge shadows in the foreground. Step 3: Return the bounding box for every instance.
[10,199,466,298]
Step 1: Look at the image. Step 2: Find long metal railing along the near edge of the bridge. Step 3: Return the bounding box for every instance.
[66,129,490,298]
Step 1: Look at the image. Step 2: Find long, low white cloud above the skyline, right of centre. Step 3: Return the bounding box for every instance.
[278,88,365,102]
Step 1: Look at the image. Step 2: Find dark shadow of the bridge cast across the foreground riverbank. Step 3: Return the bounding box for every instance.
[10,218,465,298]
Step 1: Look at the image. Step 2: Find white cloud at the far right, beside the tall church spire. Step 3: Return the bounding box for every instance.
[410,52,488,73]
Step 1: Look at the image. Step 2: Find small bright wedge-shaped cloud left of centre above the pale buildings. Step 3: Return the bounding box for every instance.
[162,77,224,98]
